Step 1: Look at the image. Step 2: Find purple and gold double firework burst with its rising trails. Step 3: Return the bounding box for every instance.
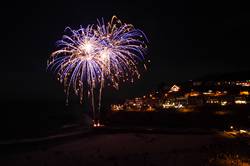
[48,16,148,124]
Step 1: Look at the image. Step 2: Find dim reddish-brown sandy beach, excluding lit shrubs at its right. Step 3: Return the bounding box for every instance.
[0,133,219,166]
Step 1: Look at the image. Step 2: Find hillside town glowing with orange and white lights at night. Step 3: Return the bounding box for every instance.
[111,80,250,112]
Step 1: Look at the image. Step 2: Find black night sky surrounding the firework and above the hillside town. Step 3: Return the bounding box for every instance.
[0,0,250,100]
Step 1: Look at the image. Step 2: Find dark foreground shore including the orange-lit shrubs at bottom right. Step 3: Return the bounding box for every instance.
[0,129,250,166]
